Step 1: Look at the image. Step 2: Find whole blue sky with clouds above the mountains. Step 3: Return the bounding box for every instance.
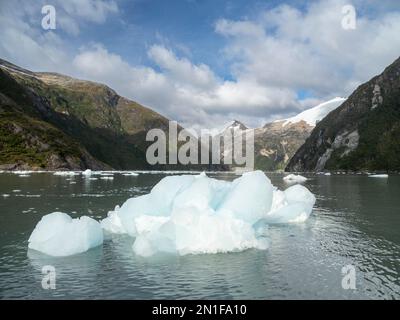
[0,0,400,129]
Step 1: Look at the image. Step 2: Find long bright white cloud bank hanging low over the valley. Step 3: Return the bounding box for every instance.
[73,44,299,126]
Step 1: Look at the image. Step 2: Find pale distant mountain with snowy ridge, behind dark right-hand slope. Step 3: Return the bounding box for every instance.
[254,98,345,171]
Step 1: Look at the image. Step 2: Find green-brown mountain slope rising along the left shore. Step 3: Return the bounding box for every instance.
[0,59,219,170]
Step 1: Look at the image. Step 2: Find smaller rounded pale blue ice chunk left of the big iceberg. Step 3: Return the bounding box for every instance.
[29,212,103,257]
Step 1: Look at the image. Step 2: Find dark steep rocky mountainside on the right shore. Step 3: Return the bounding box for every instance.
[286,58,400,171]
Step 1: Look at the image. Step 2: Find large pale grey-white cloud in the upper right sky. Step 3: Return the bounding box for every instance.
[215,0,400,97]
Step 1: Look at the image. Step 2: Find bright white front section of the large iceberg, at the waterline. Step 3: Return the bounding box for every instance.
[133,211,268,257]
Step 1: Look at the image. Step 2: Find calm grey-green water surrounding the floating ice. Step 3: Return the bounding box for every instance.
[0,173,400,299]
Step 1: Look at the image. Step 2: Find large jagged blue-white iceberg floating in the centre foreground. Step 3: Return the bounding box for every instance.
[101,171,315,256]
